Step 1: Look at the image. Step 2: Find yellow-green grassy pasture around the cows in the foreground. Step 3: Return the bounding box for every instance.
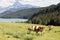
[0,22,60,40]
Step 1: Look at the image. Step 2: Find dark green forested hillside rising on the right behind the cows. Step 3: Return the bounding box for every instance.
[29,3,60,25]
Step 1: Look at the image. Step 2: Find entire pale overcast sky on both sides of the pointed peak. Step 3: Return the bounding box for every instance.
[0,0,60,7]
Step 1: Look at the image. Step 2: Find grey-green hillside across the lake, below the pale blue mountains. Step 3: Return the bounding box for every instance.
[0,8,39,18]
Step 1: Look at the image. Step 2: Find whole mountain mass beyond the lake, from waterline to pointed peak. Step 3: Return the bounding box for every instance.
[0,0,39,18]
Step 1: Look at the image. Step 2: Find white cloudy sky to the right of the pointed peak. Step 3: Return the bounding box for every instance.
[20,0,60,7]
